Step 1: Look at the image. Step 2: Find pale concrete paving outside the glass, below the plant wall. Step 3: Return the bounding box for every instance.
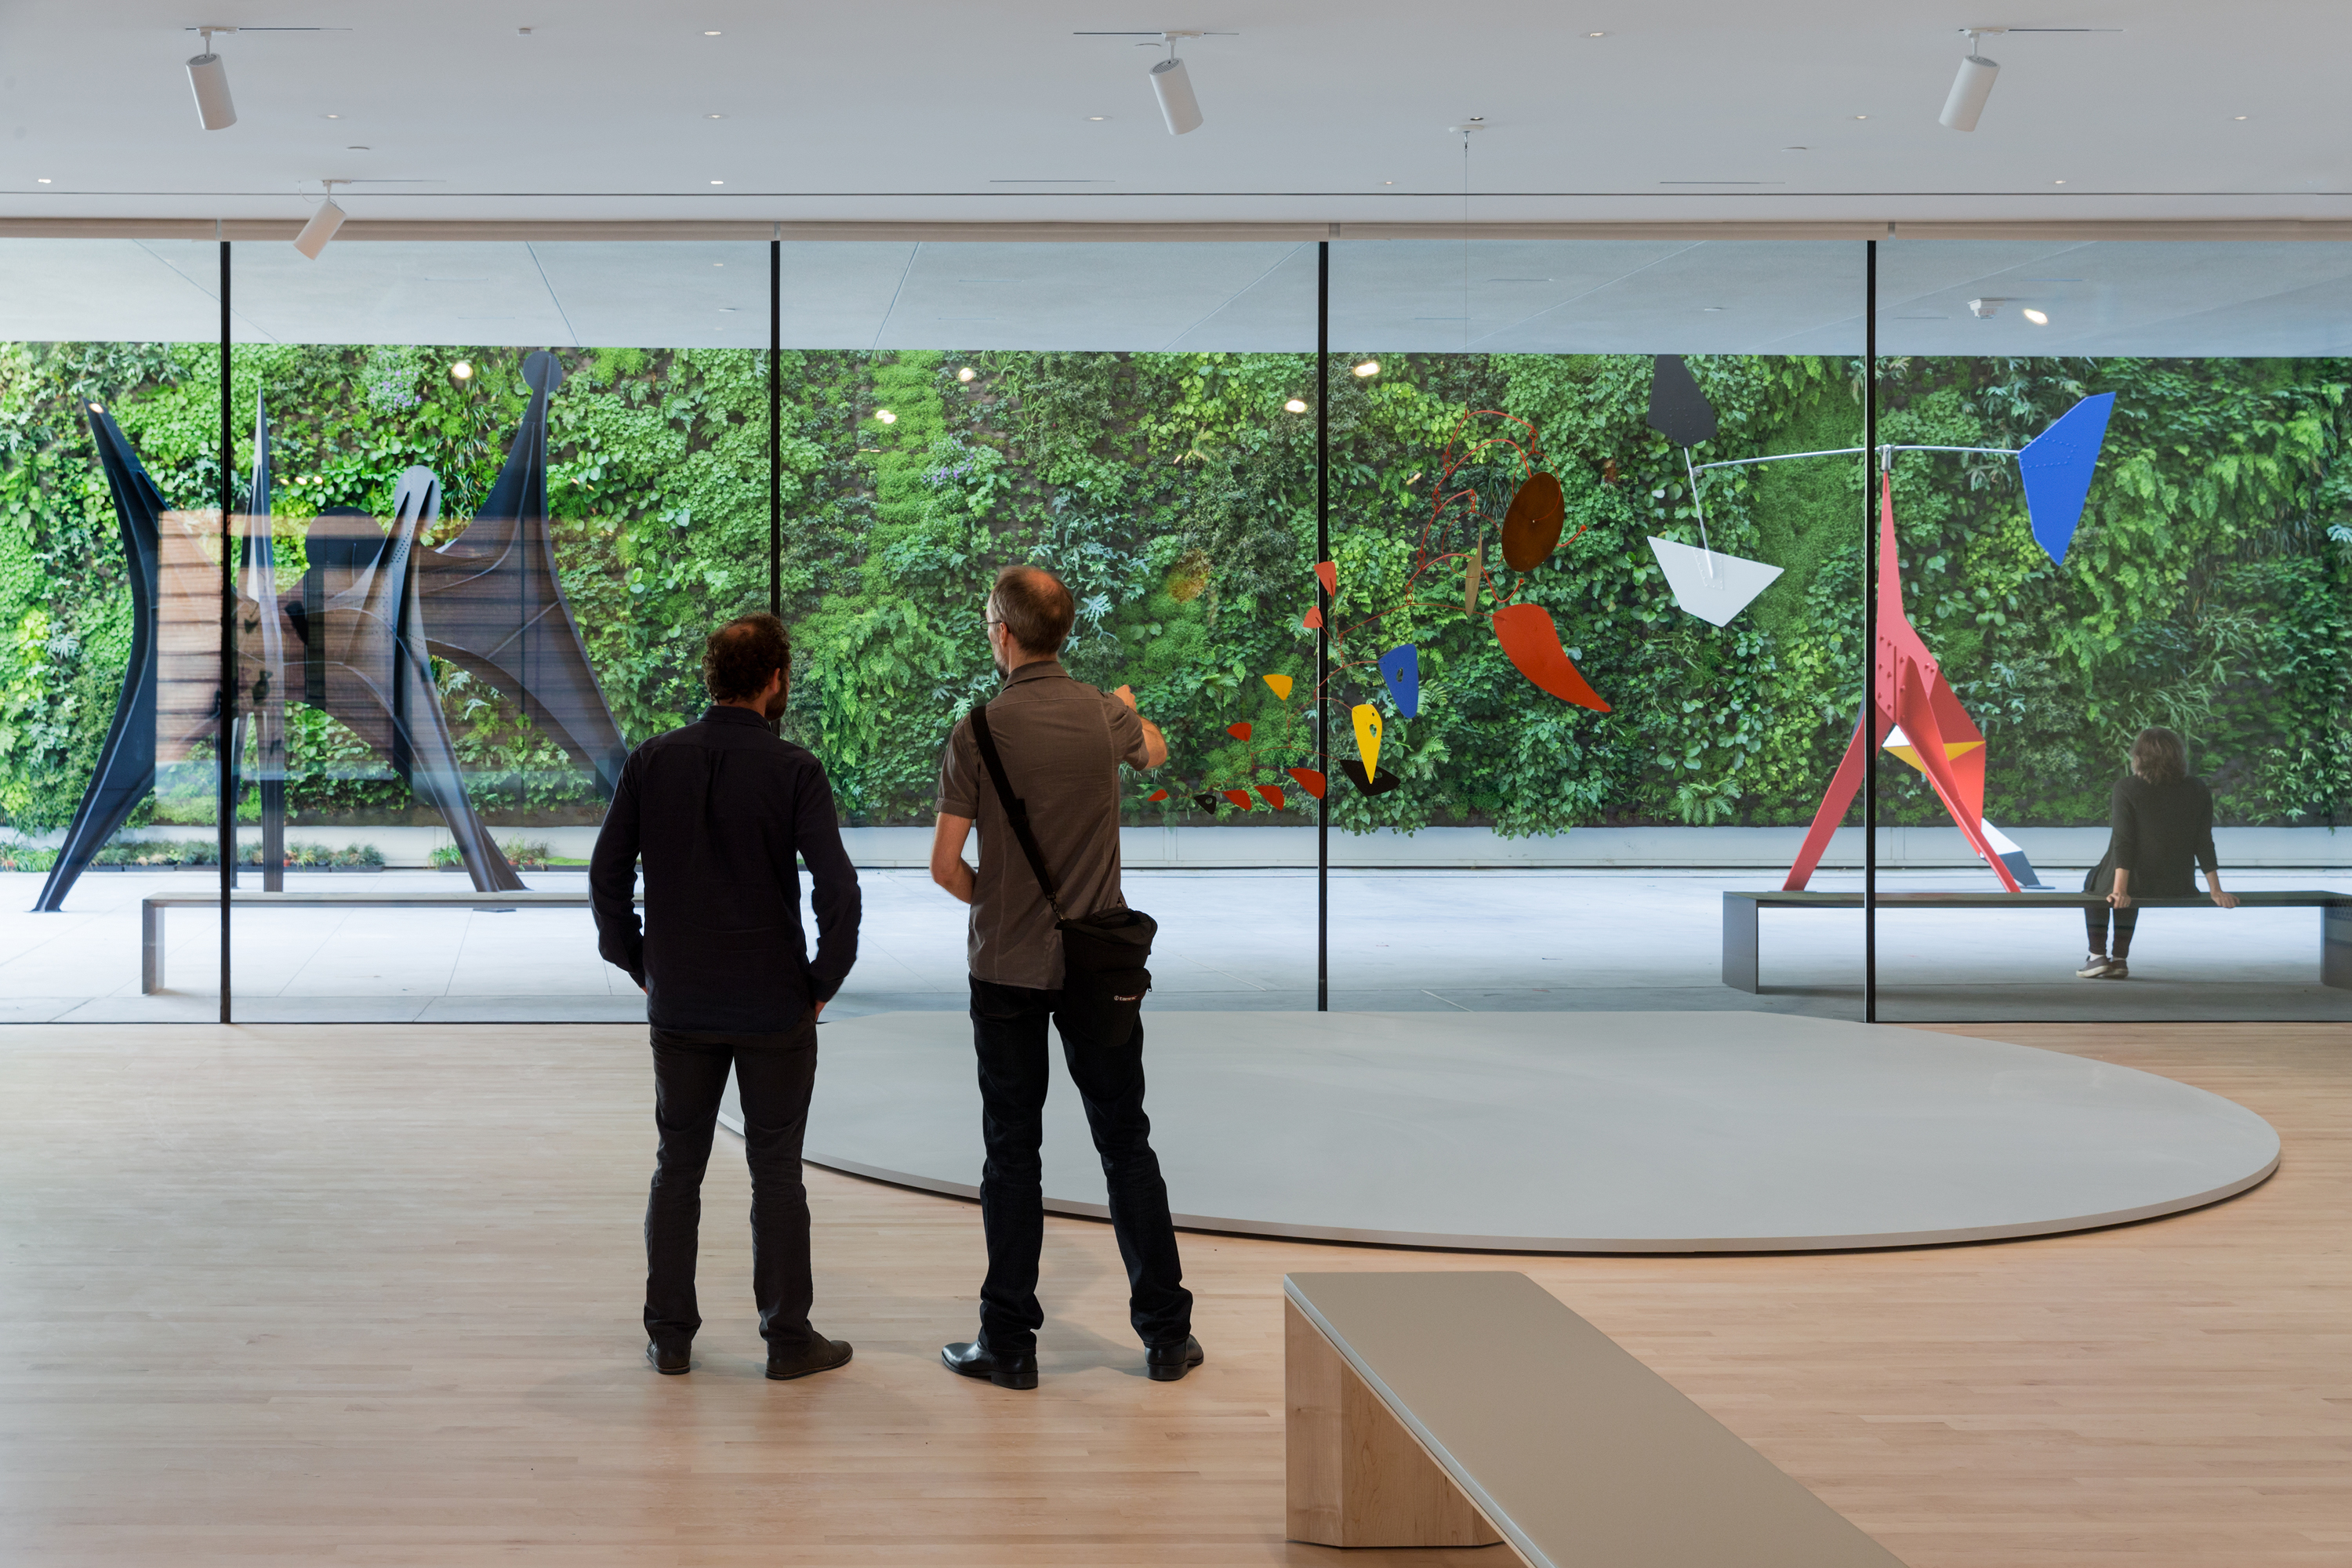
[0,869,2352,1022]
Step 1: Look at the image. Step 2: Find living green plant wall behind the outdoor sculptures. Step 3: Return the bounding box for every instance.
[0,346,2352,832]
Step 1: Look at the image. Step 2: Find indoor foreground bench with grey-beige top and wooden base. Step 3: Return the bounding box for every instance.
[1282,1274,1903,1568]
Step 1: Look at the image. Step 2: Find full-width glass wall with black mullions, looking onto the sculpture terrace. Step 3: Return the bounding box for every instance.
[0,227,2352,1020]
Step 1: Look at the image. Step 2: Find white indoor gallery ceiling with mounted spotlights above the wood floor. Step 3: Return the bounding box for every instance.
[0,0,2352,221]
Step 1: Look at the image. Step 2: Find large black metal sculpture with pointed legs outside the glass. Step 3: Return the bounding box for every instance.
[35,353,628,909]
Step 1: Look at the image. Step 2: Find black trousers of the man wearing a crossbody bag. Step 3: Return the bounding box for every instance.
[971,978,1192,1356]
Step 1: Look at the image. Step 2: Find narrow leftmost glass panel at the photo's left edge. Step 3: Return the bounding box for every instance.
[0,240,221,1022]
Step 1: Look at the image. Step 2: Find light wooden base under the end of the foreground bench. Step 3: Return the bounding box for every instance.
[1282,1300,1503,1547]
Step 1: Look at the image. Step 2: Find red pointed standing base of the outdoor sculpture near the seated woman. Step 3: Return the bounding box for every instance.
[1780,475,2018,893]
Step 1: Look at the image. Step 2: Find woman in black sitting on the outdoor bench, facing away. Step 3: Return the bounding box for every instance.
[2074,729,2237,980]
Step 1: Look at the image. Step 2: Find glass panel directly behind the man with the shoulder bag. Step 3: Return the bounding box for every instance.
[783,242,1315,1018]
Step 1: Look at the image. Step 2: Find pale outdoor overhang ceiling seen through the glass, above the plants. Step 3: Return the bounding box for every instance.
[0,240,2352,355]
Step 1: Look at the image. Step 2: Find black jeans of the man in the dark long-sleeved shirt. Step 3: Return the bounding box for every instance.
[644,1018,816,1352]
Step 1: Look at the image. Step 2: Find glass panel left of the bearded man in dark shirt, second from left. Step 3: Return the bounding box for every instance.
[235,242,769,1020]
